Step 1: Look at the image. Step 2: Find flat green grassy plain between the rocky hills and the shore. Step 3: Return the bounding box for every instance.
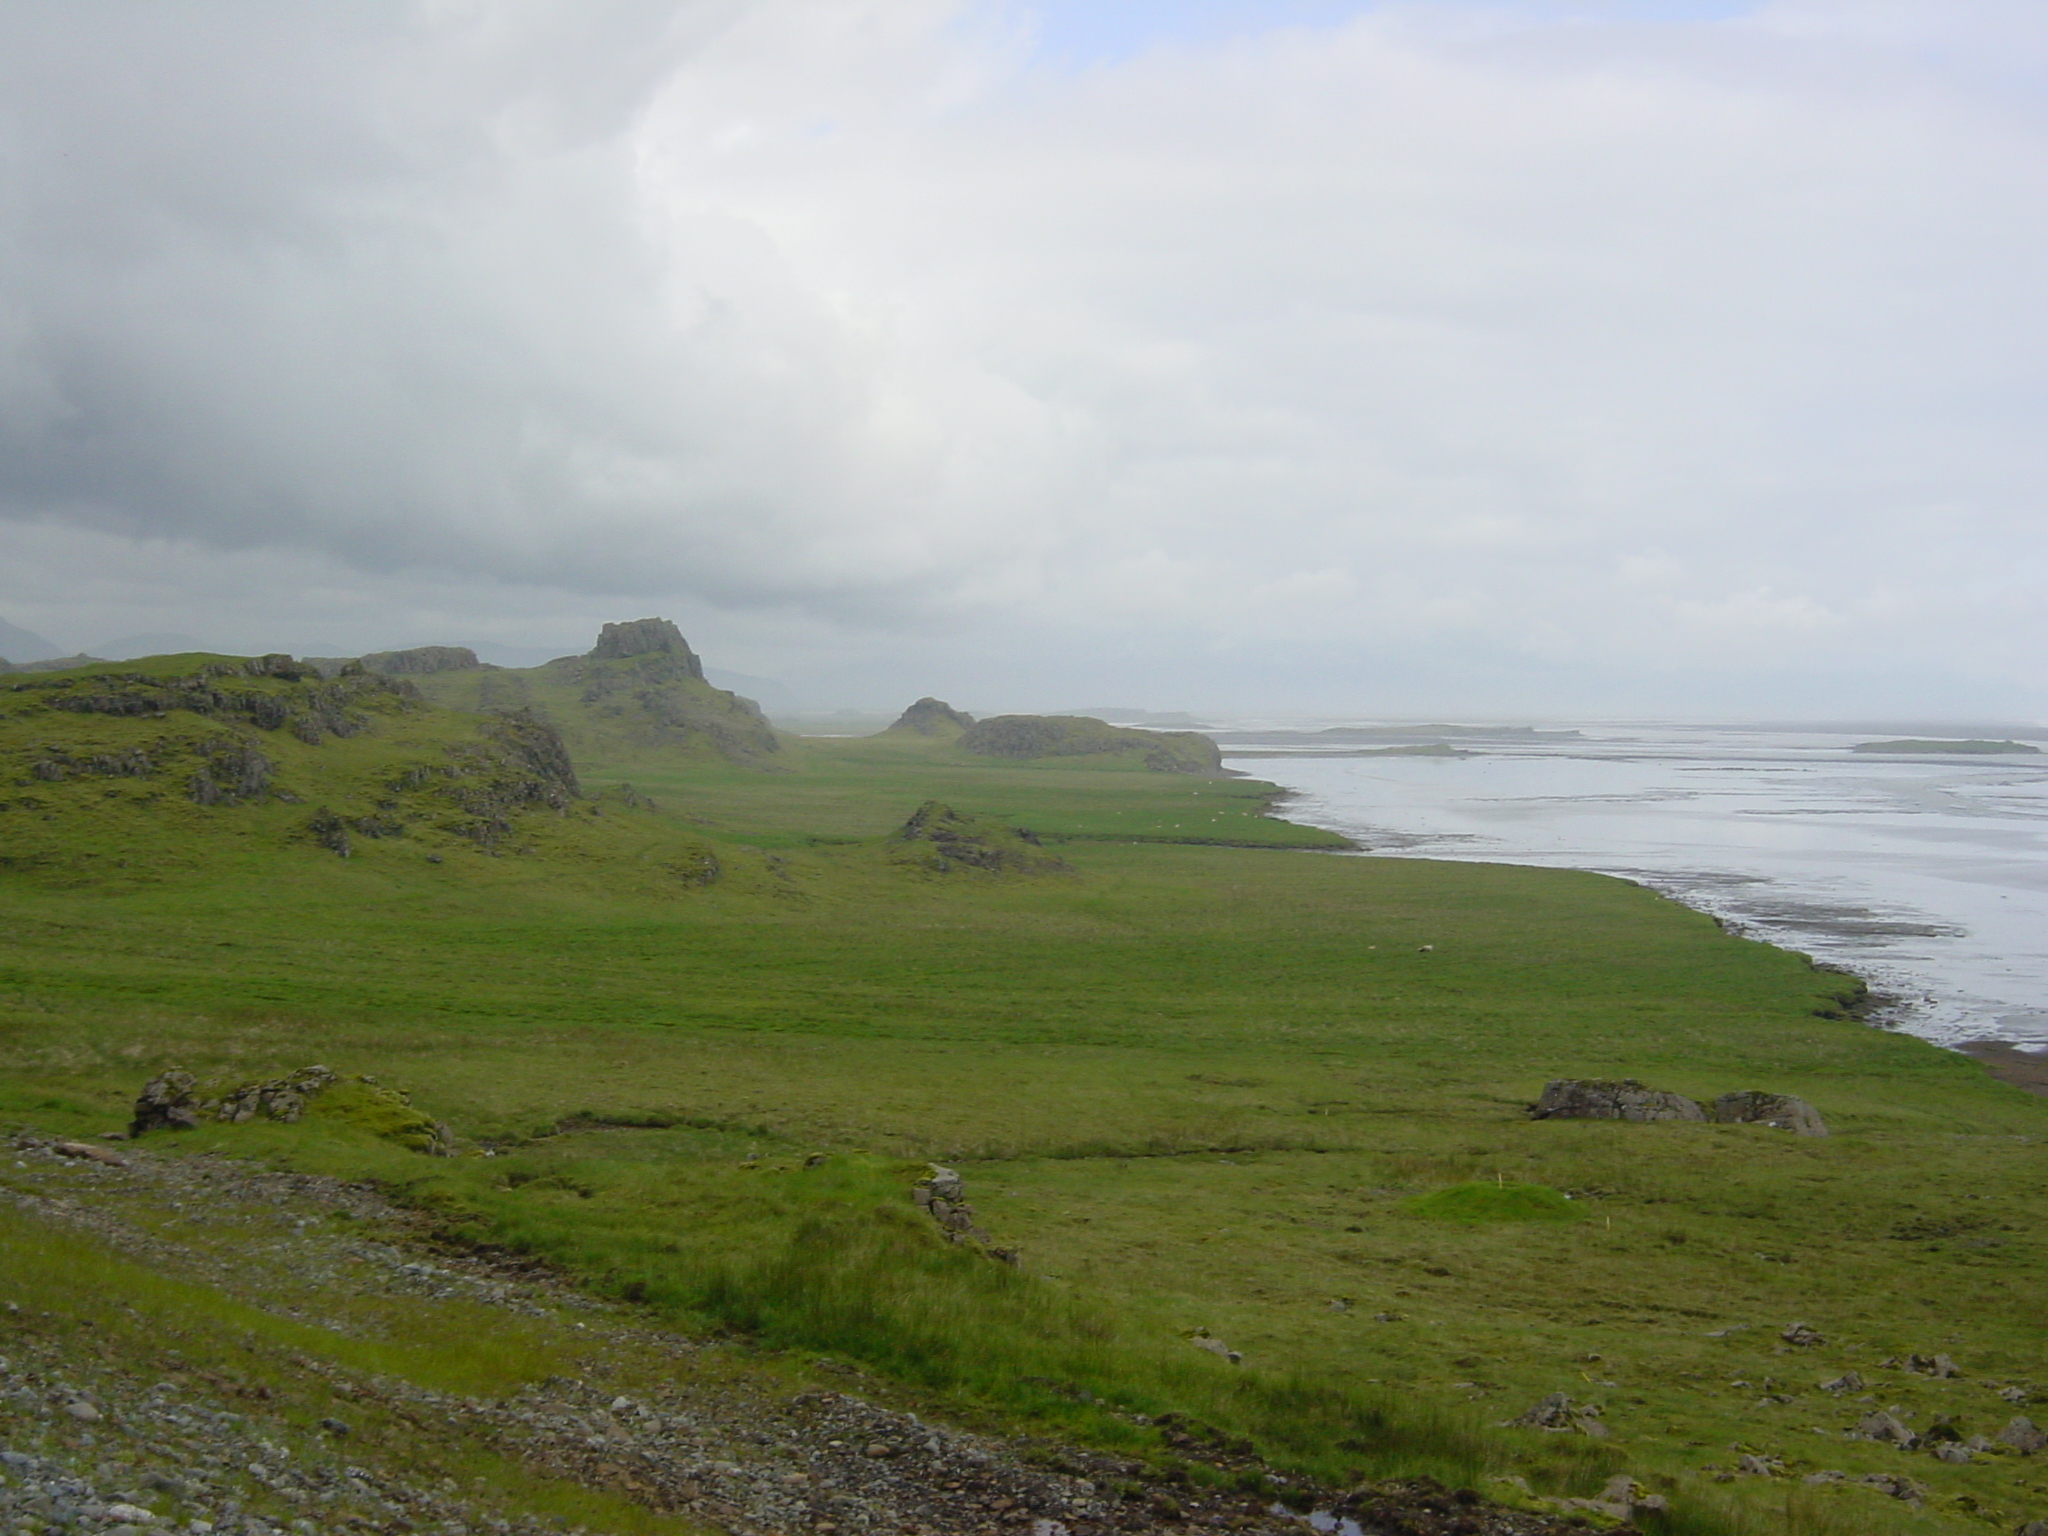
[0,663,2048,1530]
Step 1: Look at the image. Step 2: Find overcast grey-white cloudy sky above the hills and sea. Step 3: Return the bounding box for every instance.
[0,0,2048,719]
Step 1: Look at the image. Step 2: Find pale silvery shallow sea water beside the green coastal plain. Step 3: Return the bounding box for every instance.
[1219,725,2048,1049]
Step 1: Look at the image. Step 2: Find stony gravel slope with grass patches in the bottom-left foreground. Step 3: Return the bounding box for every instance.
[0,1135,1613,1536]
